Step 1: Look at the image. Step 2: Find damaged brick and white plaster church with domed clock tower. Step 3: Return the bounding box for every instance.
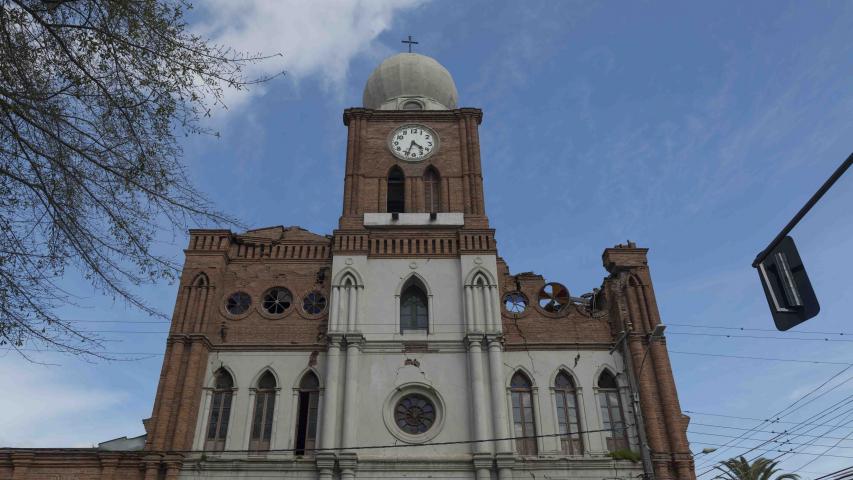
[0,53,695,480]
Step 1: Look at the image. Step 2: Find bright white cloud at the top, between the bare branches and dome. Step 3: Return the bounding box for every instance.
[193,0,425,108]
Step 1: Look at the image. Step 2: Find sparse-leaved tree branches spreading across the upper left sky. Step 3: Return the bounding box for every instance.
[0,0,280,357]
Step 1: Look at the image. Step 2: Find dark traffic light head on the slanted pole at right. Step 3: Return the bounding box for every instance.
[757,236,820,331]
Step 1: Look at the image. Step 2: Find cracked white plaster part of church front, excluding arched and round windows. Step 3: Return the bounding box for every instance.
[182,251,642,480]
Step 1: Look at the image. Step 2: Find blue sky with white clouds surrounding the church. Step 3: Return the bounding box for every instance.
[0,0,853,478]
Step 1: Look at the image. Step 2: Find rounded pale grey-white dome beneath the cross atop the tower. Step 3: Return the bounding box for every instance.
[363,53,458,110]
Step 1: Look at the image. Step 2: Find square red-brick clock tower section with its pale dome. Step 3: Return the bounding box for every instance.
[339,53,488,232]
